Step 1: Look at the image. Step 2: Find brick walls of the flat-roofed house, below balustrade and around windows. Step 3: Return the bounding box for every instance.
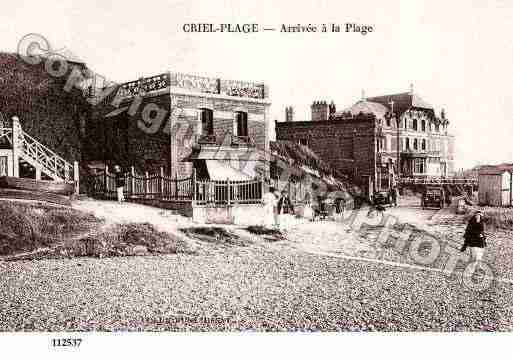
[87,85,266,178]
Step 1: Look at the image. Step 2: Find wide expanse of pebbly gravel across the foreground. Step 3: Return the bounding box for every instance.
[0,239,513,331]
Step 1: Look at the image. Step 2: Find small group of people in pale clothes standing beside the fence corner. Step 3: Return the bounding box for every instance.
[263,187,294,230]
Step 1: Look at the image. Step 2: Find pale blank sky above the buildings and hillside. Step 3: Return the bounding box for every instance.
[0,0,513,168]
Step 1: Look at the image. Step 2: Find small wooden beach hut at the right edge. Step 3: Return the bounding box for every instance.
[479,166,513,207]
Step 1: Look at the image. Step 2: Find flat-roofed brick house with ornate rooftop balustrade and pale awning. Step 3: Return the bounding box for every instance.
[89,73,270,180]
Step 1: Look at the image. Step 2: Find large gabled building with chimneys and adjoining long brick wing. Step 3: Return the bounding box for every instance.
[276,91,454,192]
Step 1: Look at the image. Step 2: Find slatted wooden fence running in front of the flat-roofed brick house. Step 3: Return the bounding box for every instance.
[91,168,263,206]
